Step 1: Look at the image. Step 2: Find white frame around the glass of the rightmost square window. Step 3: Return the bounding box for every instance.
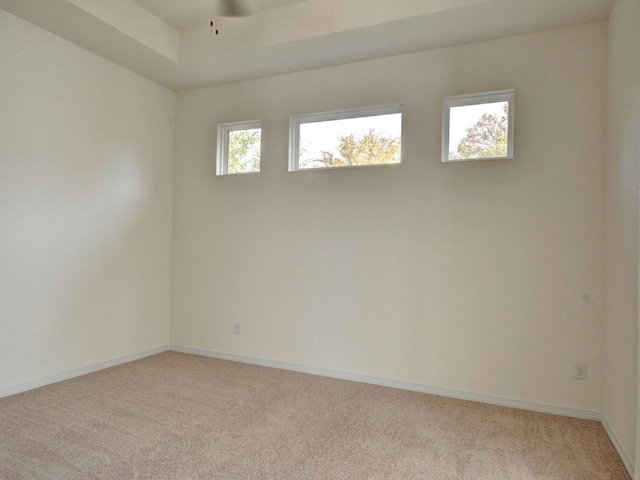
[441,89,515,163]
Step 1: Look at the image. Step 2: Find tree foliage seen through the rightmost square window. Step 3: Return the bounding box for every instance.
[449,105,509,160]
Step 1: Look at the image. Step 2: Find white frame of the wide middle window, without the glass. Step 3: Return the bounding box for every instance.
[289,103,404,172]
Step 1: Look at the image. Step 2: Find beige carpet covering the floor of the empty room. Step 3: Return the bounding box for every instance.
[0,352,629,480]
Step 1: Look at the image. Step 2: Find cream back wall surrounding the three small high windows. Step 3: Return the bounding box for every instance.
[171,23,607,412]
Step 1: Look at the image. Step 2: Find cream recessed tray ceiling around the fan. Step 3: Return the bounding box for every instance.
[0,0,614,90]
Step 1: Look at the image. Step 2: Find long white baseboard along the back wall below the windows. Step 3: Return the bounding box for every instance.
[171,345,601,421]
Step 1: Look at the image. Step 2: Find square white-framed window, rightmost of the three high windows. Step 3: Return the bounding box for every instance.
[442,90,515,162]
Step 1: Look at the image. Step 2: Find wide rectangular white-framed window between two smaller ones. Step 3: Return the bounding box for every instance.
[289,104,403,172]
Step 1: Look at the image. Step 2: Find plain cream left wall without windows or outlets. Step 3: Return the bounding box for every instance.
[0,10,175,388]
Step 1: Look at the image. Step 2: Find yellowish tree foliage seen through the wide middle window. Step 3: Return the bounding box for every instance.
[300,129,400,168]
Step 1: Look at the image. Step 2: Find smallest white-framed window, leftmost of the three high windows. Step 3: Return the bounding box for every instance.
[216,120,262,175]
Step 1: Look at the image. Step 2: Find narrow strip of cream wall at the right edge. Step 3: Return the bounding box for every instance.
[602,0,640,474]
